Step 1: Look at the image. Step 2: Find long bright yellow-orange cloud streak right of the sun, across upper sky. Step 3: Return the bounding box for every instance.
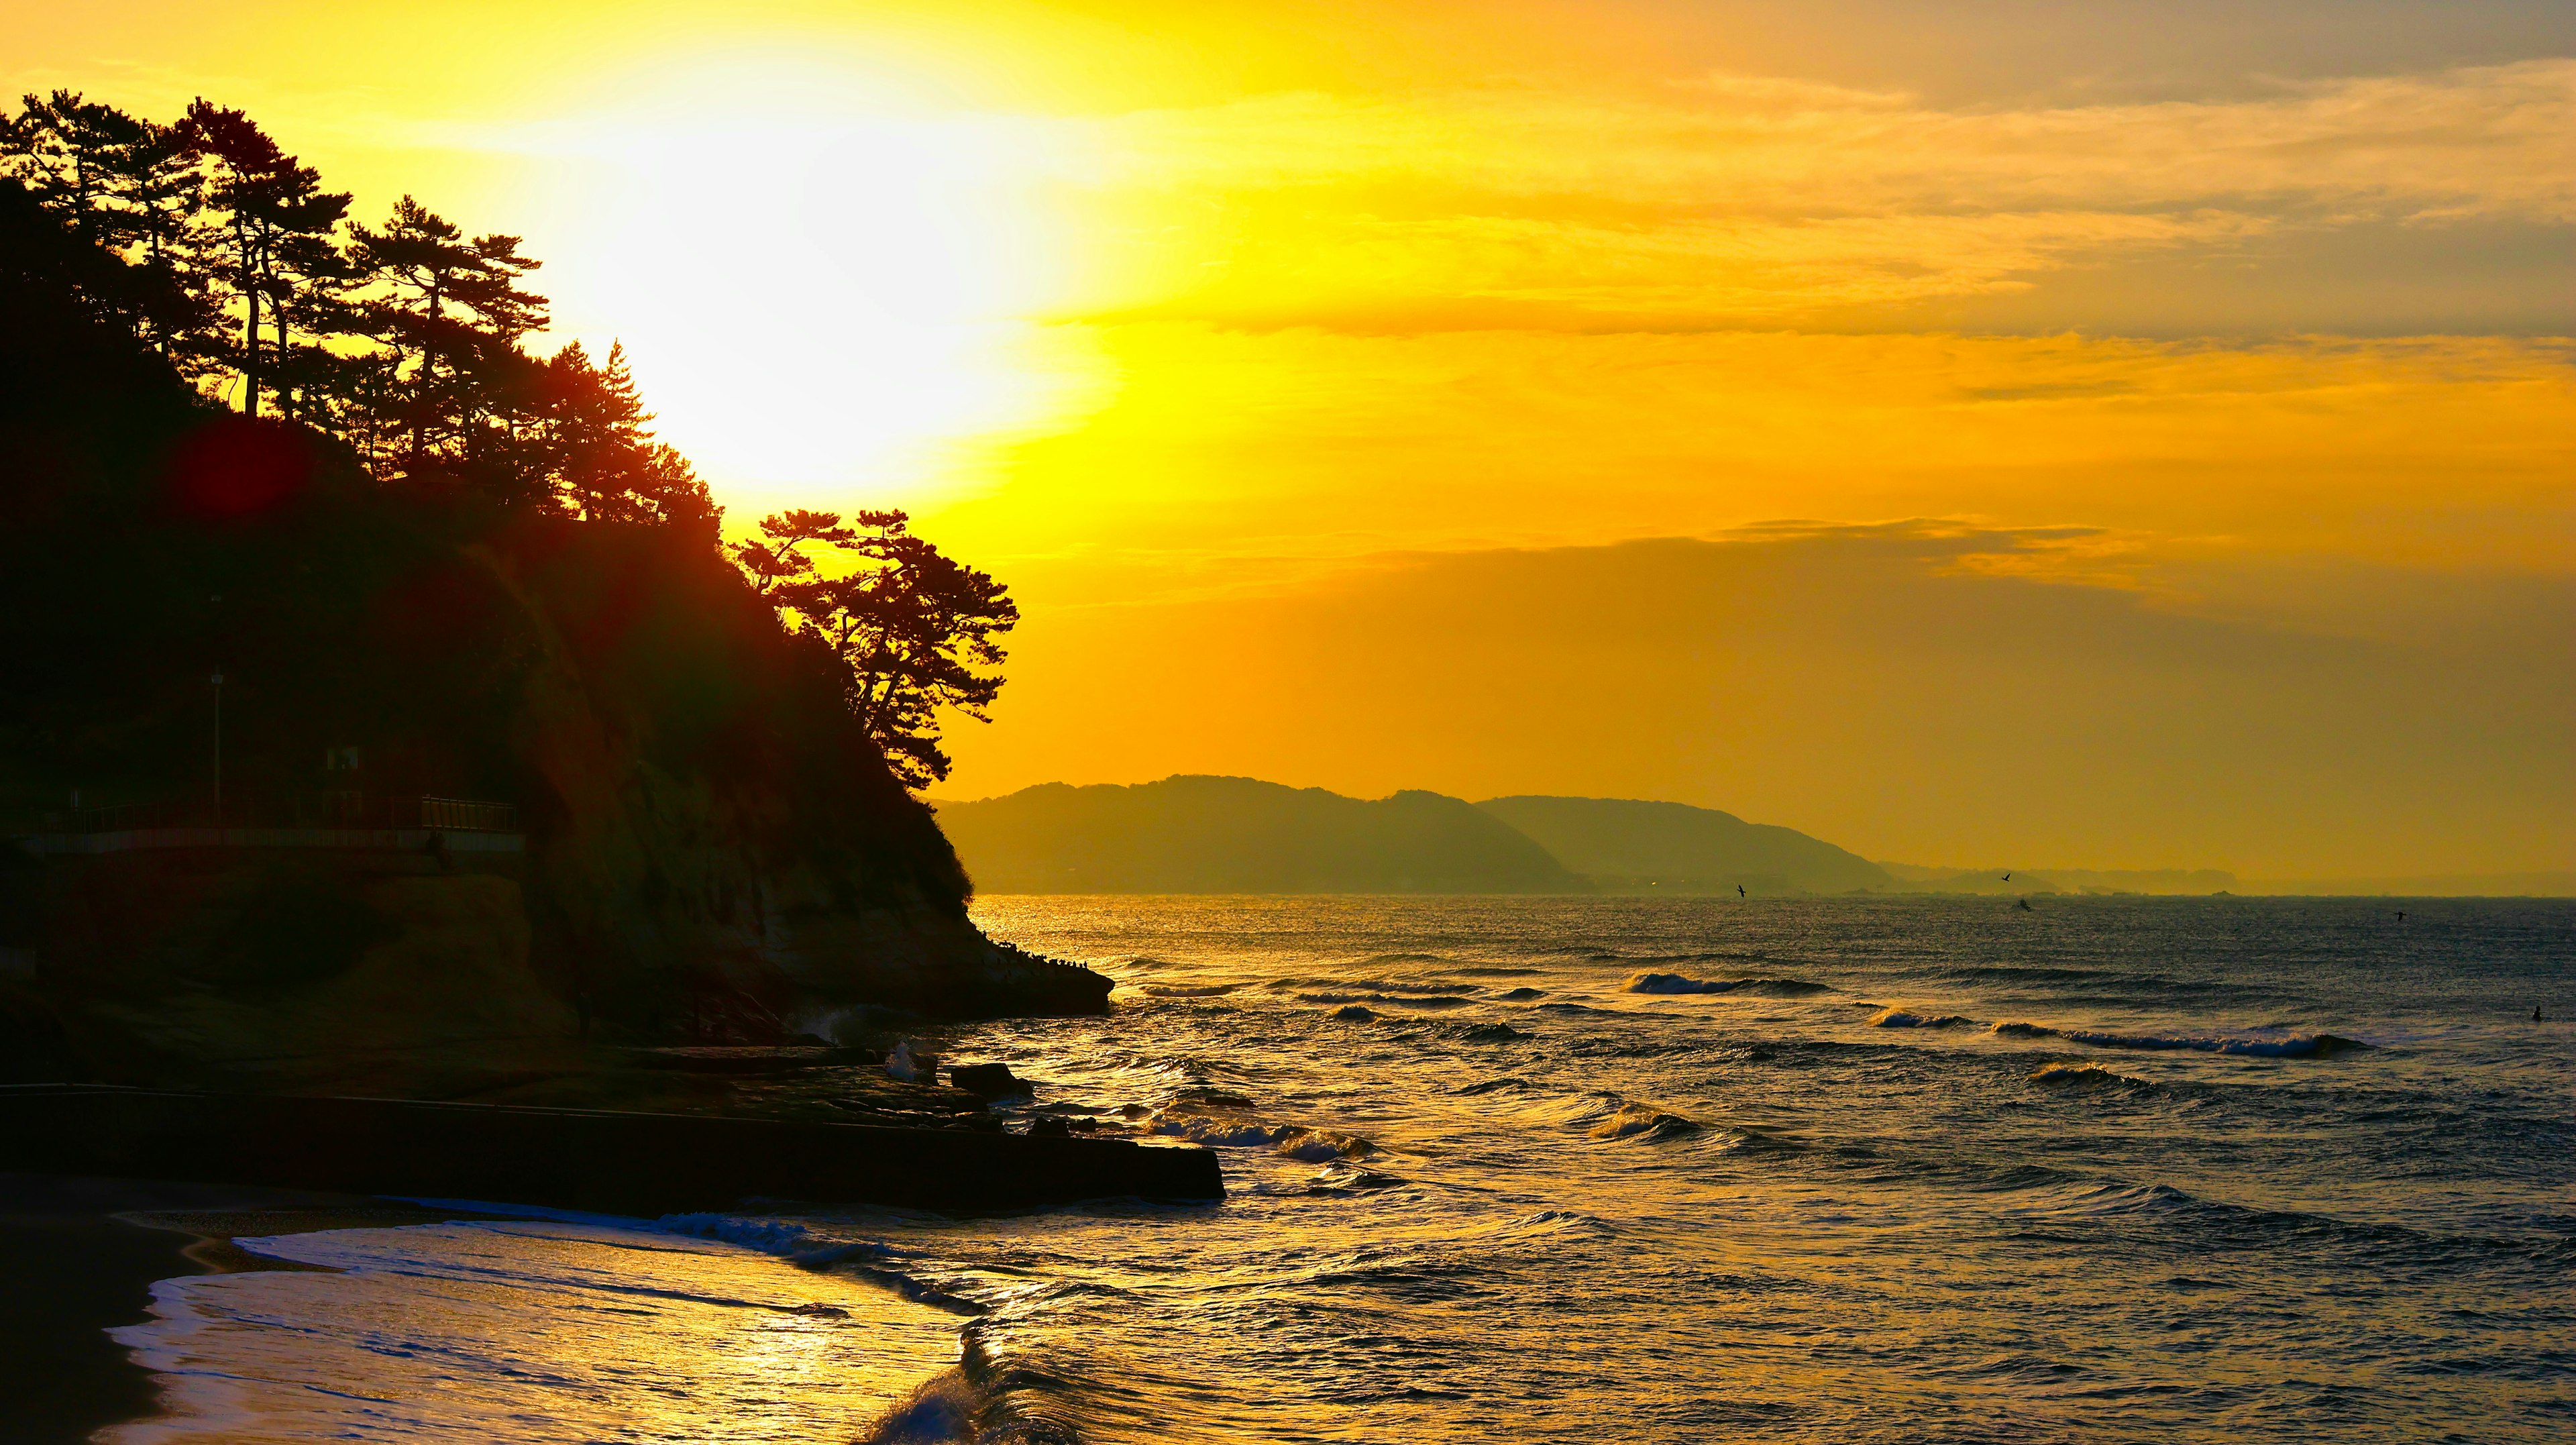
[1059,59,2576,325]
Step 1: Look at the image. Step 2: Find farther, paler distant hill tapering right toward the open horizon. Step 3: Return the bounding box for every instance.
[1476,796,1896,894]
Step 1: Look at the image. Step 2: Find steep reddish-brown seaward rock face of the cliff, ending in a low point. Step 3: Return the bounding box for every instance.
[466,533,1108,1040]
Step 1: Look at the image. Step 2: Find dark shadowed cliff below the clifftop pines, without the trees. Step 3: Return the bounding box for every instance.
[0,182,1108,1079]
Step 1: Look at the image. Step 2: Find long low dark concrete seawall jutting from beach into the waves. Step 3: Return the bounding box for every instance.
[0,1084,1226,1216]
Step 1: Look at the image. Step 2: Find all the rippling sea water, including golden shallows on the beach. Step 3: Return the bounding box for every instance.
[100,896,2576,1445]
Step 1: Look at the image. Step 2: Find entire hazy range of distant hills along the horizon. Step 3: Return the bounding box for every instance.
[938,775,1947,894]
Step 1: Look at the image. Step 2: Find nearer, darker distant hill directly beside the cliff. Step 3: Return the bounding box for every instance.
[938,775,1585,894]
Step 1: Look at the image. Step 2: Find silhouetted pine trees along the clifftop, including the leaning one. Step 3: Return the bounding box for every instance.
[0,90,1018,788]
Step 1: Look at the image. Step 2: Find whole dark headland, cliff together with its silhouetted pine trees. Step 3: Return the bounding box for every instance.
[0,93,1108,1092]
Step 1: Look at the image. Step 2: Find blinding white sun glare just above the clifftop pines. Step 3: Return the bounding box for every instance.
[486,68,1092,521]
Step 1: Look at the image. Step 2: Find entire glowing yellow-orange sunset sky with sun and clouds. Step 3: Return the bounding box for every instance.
[0,0,2576,875]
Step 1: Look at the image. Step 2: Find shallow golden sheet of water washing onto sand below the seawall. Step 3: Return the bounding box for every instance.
[103,1224,961,1445]
